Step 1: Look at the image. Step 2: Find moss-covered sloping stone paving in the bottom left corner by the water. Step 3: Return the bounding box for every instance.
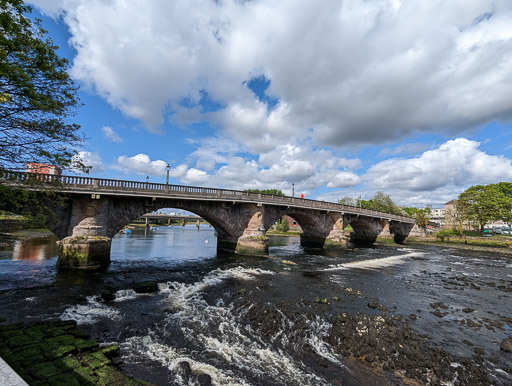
[0,321,148,386]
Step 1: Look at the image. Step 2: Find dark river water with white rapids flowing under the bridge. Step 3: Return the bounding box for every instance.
[0,226,512,385]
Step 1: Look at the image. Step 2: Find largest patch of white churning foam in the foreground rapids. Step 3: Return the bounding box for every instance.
[130,267,334,385]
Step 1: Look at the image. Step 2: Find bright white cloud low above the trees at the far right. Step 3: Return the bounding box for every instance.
[363,138,512,192]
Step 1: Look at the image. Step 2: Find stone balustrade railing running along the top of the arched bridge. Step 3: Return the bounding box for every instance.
[0,171,414,222]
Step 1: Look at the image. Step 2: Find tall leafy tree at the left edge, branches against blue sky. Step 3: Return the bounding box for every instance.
[0,0,87,171]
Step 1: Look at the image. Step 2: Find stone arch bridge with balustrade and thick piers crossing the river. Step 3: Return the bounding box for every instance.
[0,172,414,268]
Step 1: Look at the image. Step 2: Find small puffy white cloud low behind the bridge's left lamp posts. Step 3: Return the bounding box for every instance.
[112,153,187,177]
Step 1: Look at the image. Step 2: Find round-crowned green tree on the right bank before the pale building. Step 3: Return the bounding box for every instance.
[457,184,508,234]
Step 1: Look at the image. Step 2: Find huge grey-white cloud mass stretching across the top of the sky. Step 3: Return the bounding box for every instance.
[33,0,512,148]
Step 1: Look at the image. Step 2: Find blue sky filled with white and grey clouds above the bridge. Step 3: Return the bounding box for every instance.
[29,0,512,207]
